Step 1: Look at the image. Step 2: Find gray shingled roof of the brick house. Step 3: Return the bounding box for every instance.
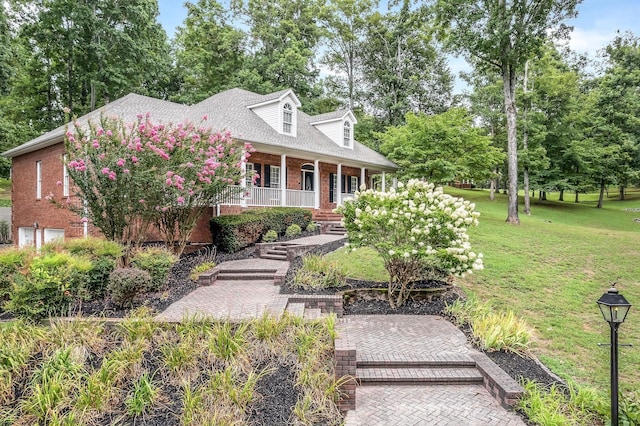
[2,89,398,171]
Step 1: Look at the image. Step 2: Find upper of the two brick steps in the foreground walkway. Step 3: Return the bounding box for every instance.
[356,353,476,368]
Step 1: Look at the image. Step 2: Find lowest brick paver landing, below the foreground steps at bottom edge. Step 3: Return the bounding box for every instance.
[345,385,525,426]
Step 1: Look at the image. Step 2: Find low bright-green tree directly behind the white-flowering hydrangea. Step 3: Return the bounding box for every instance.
[378,108,504,183]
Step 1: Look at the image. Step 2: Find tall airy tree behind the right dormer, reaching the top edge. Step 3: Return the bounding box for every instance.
[362,0,453,126]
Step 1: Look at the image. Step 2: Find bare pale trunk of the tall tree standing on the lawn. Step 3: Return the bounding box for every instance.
[502,65,520,224]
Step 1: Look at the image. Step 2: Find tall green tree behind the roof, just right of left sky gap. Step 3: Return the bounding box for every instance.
[174,0,246,103]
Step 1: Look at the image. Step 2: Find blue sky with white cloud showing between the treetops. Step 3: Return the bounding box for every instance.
[158,0,640,93]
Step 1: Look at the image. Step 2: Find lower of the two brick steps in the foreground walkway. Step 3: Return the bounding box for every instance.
[356,367,483,386]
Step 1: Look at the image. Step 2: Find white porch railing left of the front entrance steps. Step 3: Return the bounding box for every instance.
[220,186,315,208]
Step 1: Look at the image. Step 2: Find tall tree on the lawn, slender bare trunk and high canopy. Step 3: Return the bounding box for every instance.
[436,0,581,223]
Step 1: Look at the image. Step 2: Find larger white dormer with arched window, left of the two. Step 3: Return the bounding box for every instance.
[247,89,302,137]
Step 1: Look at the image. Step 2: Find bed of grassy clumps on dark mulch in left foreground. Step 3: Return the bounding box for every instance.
[0,311,342,426]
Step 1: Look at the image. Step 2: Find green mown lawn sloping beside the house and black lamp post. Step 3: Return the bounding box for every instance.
[334,188,640,392]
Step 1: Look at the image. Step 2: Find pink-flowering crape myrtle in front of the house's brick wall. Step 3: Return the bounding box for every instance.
[57,114,252,254]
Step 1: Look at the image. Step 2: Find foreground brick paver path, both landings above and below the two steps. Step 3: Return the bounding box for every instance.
[338,315,525,426]
